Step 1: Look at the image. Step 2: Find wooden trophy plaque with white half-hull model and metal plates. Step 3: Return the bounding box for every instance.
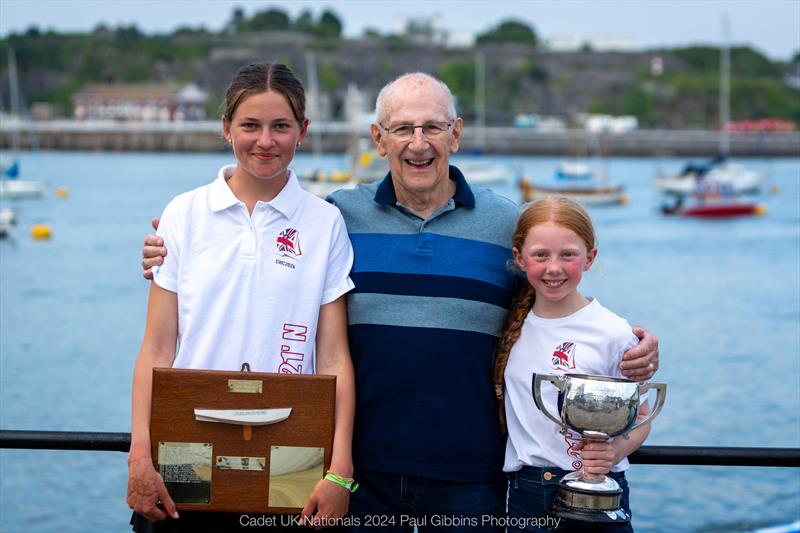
[150,368,336,514]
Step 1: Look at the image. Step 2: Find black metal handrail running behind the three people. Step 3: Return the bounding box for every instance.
[0,429,800,468]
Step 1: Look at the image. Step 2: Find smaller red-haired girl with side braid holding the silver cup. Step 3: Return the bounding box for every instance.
[494,197,650,531]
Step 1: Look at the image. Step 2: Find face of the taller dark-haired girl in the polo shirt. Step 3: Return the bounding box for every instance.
[222,91,308,186]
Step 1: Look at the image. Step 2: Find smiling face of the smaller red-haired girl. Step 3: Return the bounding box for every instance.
[514,222,597,310]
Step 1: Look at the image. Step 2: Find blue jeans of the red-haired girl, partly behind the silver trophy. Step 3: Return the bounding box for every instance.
[507,466,633,533]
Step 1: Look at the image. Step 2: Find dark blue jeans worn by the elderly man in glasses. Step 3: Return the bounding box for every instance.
[346,470,506,533]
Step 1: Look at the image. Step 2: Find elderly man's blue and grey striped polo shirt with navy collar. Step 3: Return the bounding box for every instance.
[329,166,519,481]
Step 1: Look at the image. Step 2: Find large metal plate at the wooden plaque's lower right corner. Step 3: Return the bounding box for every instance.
[268,446,325,507]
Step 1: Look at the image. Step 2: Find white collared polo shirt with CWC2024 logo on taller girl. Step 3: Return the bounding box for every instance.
[153,165,353,374]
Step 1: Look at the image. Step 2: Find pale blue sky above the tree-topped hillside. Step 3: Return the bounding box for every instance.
[0,0,800,60]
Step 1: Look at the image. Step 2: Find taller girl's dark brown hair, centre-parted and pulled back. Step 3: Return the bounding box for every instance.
[223,63,306,125]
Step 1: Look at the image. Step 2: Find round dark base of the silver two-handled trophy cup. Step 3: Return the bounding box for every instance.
[548,477,631,526]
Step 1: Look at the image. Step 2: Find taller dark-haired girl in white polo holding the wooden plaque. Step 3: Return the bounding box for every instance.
[128,63,355,532]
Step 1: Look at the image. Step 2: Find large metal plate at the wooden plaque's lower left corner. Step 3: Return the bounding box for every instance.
[158,442,213,503]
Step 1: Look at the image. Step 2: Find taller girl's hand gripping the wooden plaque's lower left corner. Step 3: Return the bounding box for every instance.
[128,457,178,522]
